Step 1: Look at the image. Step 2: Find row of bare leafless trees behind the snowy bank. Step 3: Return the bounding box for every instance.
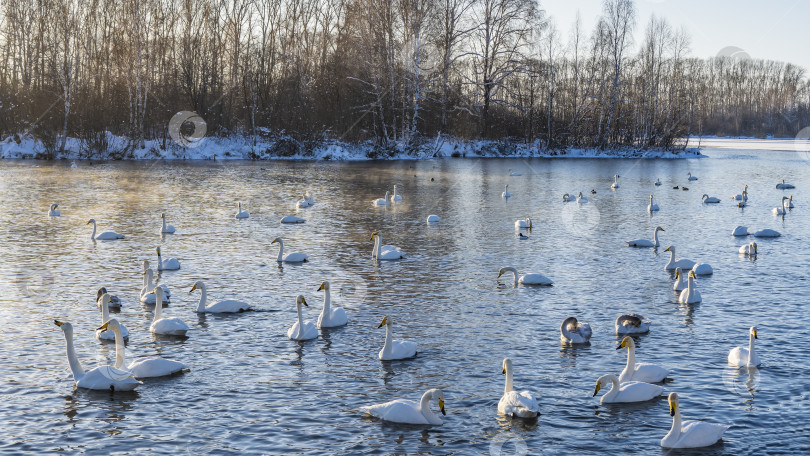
[0,0,810,157]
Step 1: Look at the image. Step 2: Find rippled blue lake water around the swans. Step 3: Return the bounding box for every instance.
[0,148,810,455]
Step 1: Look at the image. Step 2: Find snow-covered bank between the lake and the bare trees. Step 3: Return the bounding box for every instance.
[0,133,703,161]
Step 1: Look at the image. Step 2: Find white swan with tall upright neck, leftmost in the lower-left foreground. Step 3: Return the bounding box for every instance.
[53,320,142,391]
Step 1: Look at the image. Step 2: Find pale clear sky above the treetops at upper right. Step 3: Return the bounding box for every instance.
[540,0,810,71]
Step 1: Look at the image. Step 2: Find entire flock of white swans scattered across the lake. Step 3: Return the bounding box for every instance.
[48,169,795,448]
